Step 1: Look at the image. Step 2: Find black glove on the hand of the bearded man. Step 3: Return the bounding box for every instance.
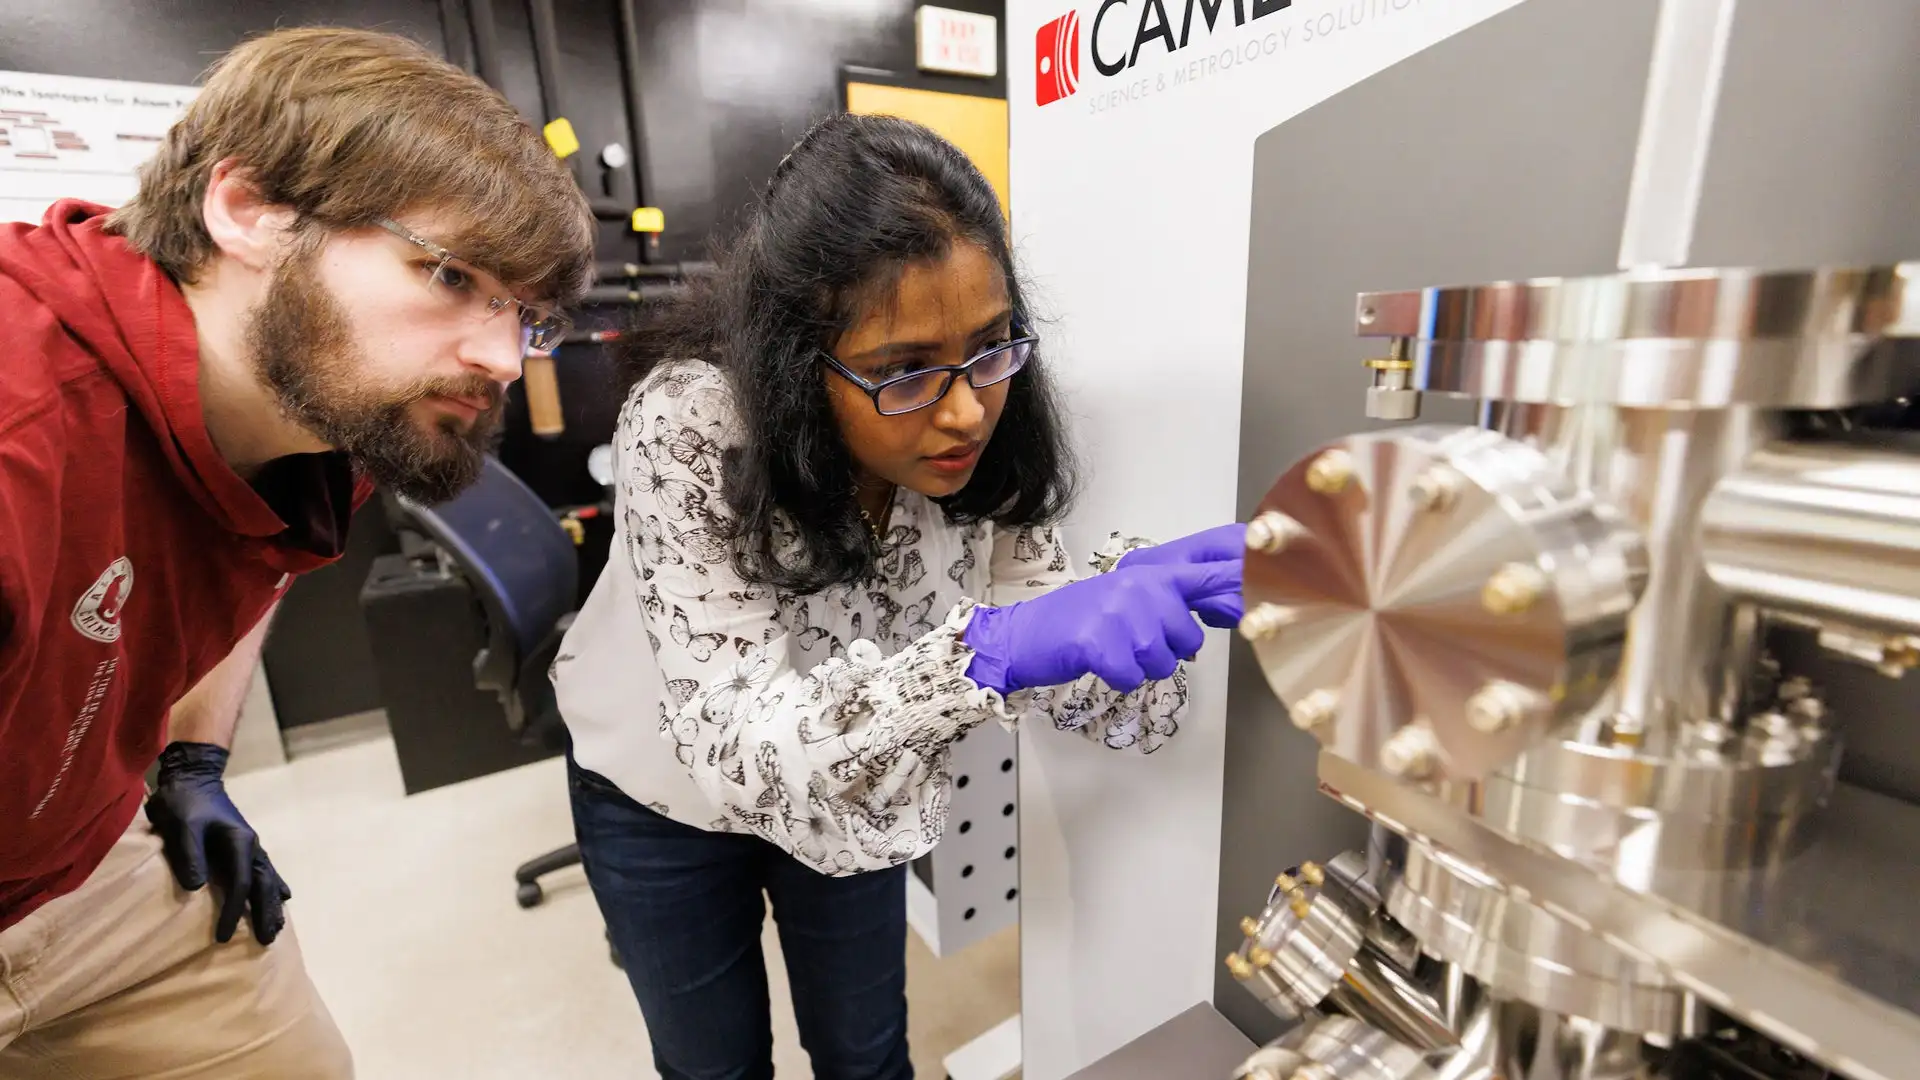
[146,742,294,945]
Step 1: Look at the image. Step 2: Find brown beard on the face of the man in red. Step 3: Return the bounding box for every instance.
[246,252,503,505]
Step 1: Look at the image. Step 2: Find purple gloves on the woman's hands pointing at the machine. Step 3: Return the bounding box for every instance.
[964,561,1240,694]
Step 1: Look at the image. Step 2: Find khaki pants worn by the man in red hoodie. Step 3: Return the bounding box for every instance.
[0,815,353,1080]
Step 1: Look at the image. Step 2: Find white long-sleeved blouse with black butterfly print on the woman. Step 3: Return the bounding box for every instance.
[553,361,1187,874]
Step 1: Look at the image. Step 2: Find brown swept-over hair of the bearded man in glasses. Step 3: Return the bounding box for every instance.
[108,27,593,304]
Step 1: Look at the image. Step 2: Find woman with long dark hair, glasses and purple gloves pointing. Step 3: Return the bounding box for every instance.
[555,115,1242,1080]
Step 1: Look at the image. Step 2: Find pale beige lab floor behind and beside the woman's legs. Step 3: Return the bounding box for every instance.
[228,726,1020,1080]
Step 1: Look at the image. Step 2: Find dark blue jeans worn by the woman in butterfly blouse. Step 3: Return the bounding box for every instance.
[568,761,914,1080]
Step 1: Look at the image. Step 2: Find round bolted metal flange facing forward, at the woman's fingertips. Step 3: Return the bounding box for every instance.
[1242,425,1645,780]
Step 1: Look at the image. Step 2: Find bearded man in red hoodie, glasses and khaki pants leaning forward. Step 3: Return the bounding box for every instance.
[0,29,593,1080]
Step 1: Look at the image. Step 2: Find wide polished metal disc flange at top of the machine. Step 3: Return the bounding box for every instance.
[1356,263,1920,409]
